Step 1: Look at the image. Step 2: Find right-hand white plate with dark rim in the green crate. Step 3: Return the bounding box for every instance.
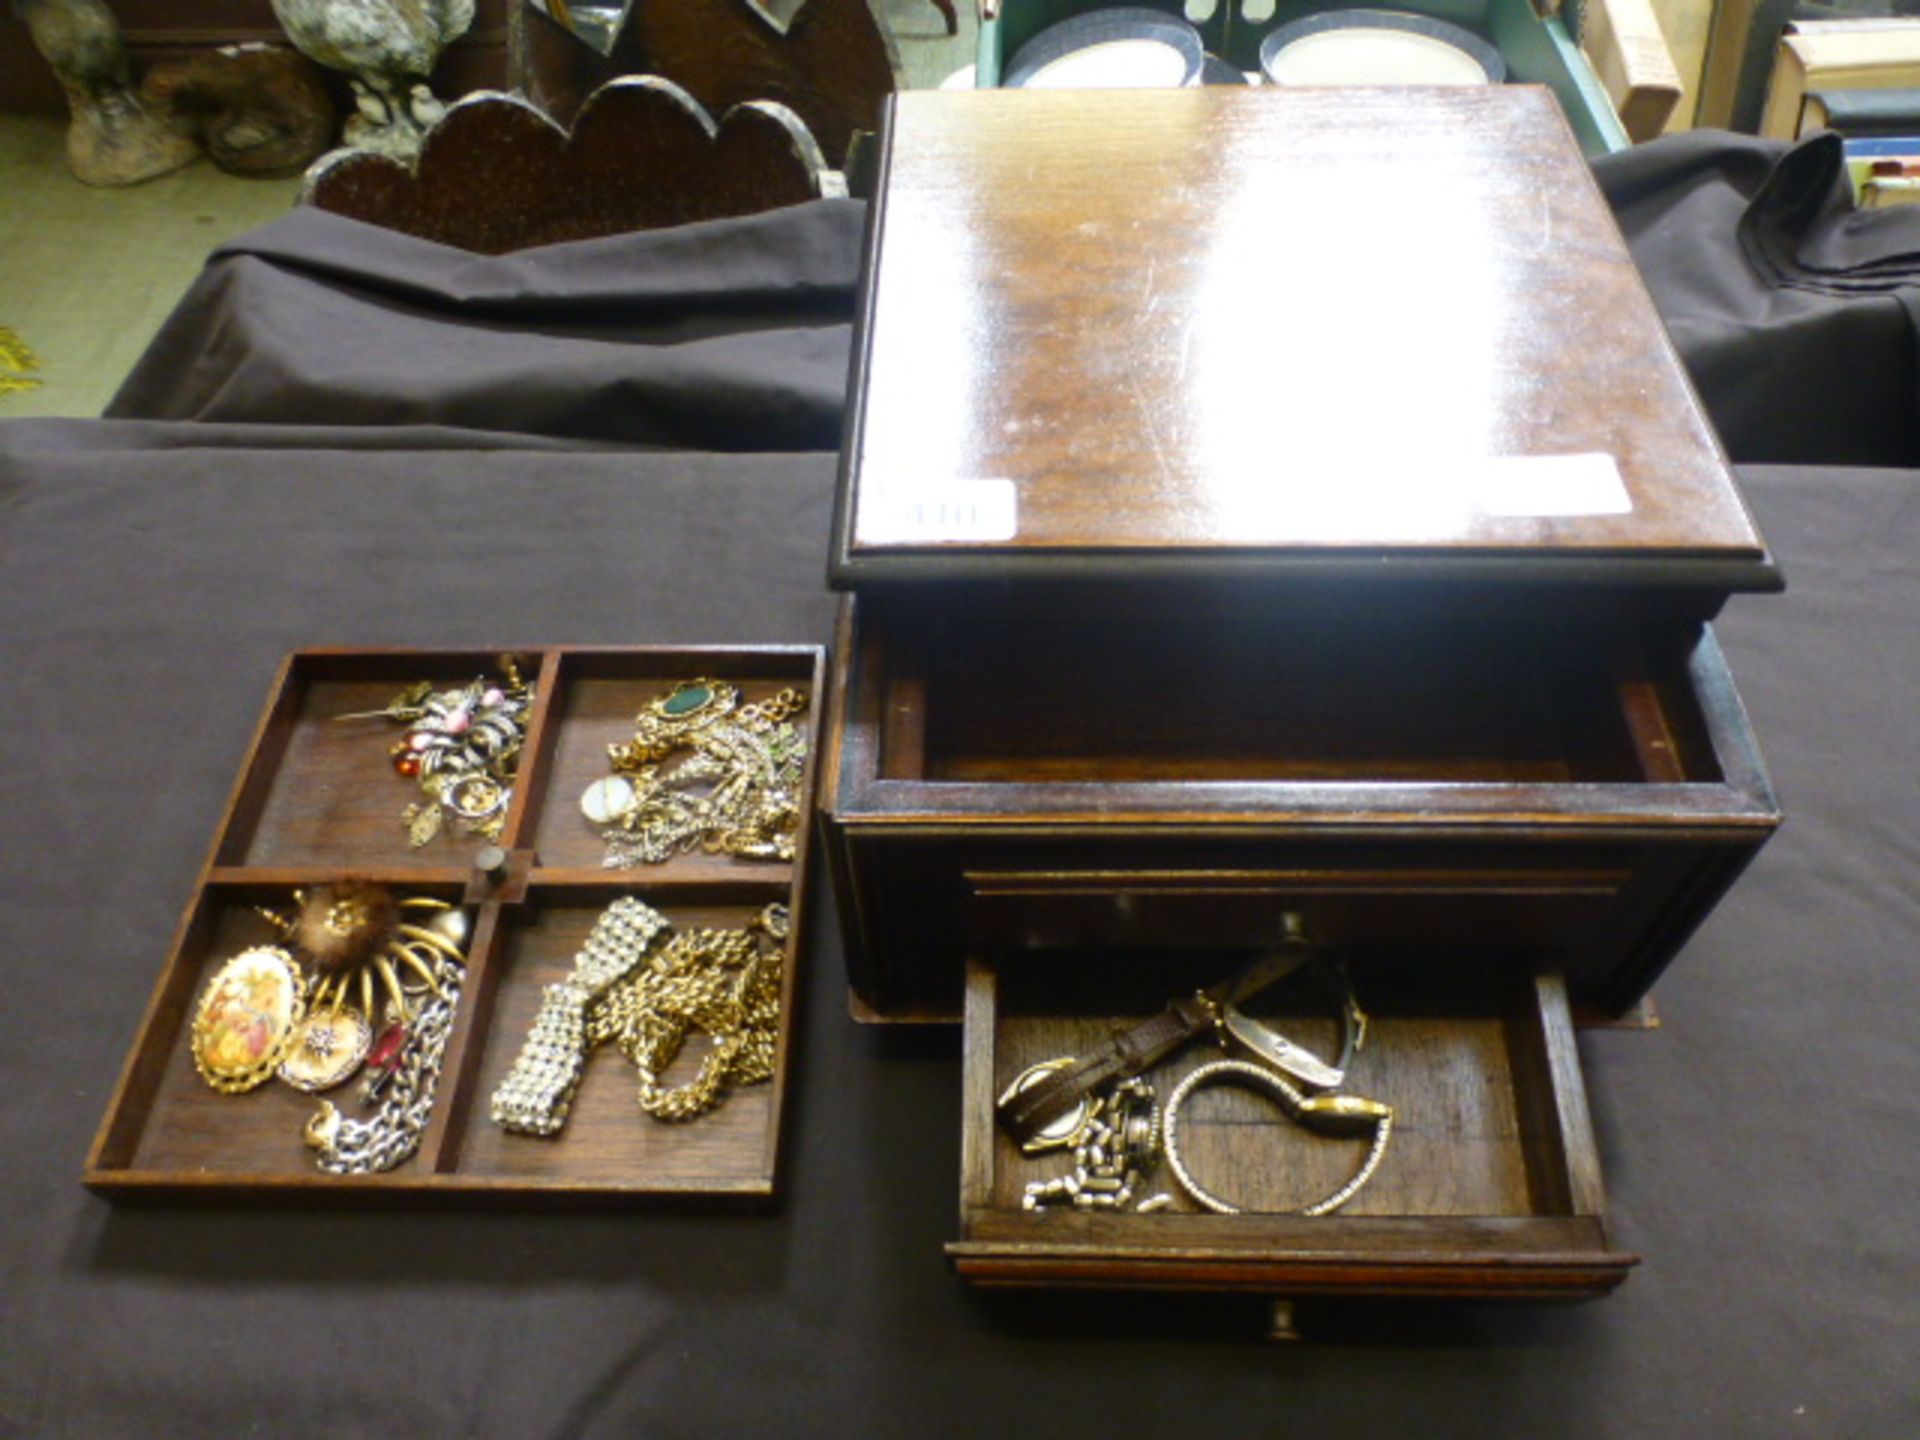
[1260,10,1507,86]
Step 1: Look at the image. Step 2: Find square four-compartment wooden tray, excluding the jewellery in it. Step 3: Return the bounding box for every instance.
[84,647,826,1204]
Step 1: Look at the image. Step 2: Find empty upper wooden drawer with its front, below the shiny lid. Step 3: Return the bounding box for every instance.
[824,593,1780,1020]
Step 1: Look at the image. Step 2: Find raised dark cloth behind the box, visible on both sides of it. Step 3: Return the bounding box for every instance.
[90,131,1920,465]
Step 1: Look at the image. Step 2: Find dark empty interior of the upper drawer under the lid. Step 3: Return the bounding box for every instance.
[871,607,1722,785]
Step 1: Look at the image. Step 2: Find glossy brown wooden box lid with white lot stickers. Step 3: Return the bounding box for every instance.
[833,86,1778,595]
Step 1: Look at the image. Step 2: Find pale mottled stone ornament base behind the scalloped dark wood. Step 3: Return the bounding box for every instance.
[273,0,474,159]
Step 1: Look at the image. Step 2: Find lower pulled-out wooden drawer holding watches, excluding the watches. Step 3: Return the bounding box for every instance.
[948,950,1638,1300]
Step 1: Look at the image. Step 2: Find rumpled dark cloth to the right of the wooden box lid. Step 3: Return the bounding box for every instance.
[1594,131,1920,467]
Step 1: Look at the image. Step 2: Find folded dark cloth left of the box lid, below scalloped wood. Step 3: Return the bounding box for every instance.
[97,200,866,451]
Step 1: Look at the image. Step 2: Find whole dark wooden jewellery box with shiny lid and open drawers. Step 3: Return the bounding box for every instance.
[822,86,1780,1296]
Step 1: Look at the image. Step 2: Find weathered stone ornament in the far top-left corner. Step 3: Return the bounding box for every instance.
[13,0,200,184]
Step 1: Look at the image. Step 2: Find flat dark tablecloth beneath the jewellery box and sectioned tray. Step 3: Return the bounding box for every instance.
[0,439,1920,1440]
